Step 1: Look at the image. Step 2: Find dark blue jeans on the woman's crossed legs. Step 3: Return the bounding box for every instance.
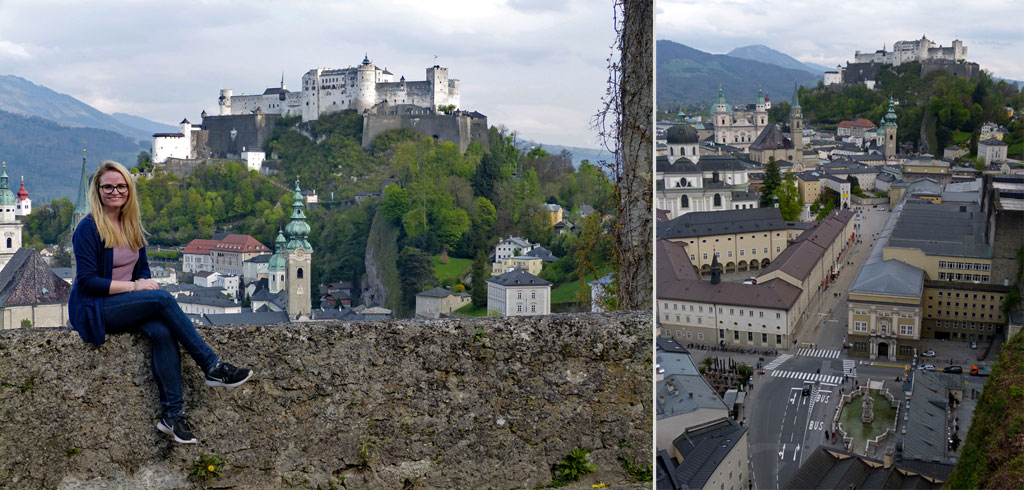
[103,289,220,417]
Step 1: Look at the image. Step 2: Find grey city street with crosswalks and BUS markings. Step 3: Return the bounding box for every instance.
[690,206,998,489]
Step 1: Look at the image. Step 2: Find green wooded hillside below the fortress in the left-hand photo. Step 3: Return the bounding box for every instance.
[26,112,614,305]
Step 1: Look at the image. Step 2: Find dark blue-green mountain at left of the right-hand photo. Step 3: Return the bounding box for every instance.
[654,40,819,109]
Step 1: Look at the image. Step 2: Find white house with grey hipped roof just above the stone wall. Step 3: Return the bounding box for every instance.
[487,269,551,316]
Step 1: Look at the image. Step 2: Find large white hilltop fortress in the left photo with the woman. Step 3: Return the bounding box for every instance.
[153,56,487,163]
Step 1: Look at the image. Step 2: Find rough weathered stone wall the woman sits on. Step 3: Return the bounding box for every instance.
[0,312,652,489]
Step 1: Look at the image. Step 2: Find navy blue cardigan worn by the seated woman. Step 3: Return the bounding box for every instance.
[68,215,151,346]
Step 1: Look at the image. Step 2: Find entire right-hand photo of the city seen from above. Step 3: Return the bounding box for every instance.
[654,2,1024,490]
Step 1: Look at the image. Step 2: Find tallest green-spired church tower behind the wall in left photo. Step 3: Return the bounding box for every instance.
[285,180,313,320]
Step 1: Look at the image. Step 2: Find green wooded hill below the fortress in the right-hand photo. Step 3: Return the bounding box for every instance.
[798,62,1024,158]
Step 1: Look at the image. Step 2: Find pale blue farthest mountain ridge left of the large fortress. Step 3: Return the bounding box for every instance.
[0,75,175,143]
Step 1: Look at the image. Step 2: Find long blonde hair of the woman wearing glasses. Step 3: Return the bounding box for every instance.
[89,160,145,251]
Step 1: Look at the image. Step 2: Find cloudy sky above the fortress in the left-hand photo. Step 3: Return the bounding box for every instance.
[0,0,613,147]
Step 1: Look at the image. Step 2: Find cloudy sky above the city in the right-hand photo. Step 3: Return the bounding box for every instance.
[654,0,1024,81]
